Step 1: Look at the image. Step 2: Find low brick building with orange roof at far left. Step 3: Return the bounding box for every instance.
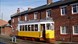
[0,20,12,36]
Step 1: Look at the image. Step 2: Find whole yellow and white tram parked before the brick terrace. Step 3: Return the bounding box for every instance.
[17,20,55,41]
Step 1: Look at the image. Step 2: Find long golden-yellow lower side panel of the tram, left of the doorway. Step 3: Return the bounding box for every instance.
[18,31,41,38]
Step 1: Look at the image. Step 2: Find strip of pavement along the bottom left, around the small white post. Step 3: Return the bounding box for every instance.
[0,35,49,44]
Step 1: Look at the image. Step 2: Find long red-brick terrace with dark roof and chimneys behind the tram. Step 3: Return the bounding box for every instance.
[11,0,78,42]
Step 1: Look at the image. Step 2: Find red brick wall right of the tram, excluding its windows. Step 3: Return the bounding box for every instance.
[52,6,78,42]
